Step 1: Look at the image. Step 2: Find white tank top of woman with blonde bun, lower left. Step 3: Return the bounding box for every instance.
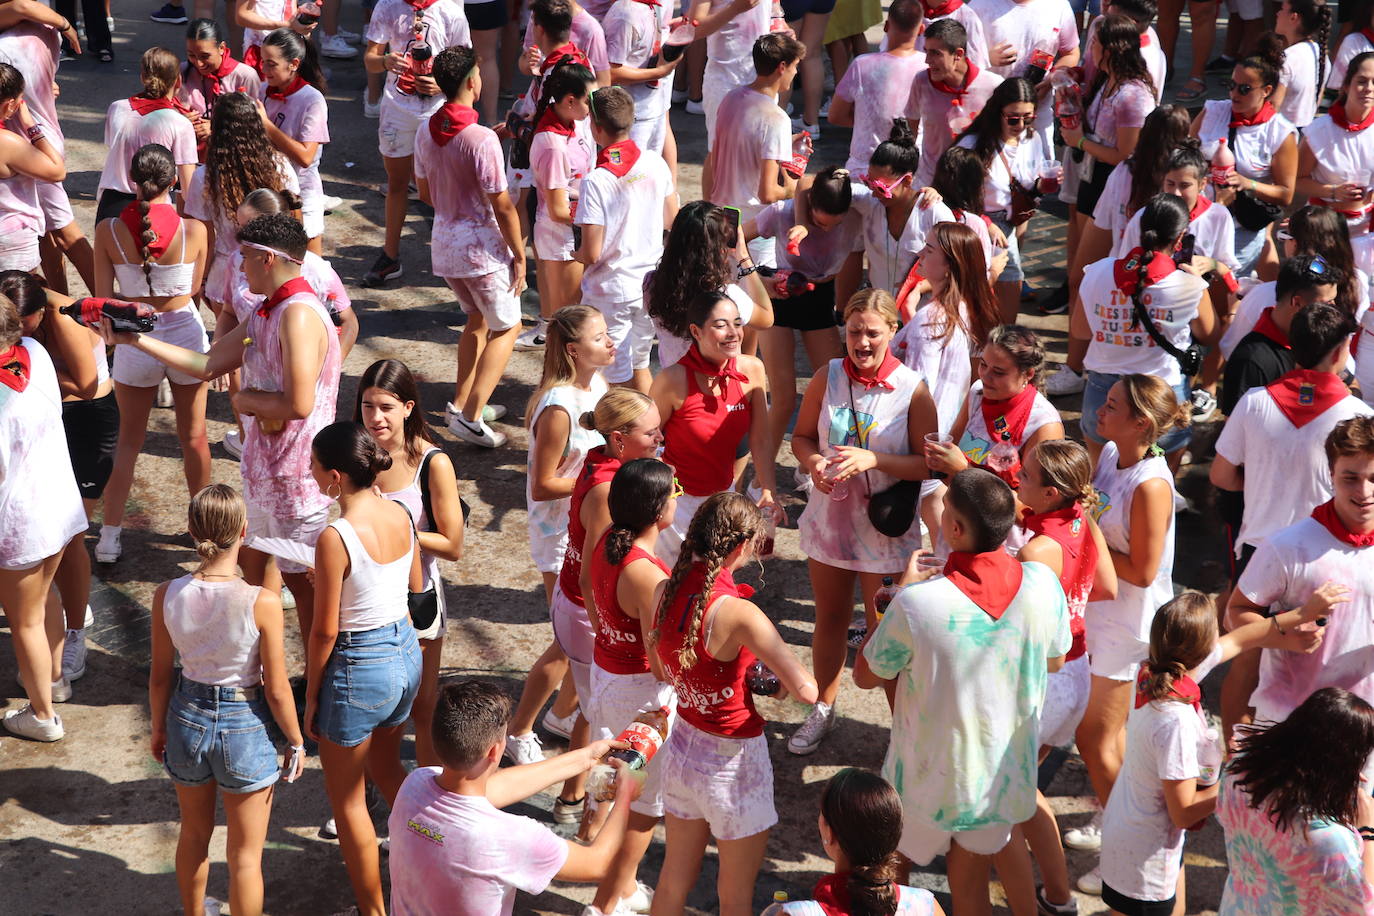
[162,575,262,687]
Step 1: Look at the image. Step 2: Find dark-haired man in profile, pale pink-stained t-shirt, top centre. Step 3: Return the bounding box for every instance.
[702,32,807,266]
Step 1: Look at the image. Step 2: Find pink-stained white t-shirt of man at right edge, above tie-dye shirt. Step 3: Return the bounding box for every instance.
[1237,518,1374,722]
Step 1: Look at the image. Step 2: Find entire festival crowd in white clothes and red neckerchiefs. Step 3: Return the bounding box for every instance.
[0,0,1374,916]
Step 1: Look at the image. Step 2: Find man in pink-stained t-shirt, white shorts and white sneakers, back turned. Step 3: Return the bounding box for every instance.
[415,48,525,448]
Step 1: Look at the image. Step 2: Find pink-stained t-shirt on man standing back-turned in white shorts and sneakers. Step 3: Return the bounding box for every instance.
[415,124,511,279]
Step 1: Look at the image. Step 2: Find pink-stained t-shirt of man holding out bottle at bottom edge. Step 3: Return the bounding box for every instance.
[387,766,567,916]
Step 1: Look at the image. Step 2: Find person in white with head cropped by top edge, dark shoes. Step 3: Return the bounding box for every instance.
[363,0,473,287]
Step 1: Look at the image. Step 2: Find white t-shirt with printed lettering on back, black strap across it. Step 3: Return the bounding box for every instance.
[1079,256,1220,386]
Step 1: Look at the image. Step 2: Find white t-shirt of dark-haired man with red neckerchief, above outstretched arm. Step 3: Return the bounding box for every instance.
[1216,387,1374,556]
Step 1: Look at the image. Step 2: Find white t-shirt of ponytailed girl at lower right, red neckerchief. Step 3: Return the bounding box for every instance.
[1102,645,1221,901]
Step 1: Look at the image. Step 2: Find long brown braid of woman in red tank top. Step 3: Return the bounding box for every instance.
[650,492,763,669]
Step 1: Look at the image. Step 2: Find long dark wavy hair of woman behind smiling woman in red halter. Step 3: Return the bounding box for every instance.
[644,201,735,341]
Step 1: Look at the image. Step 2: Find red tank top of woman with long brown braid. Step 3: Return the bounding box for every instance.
[658,562,764,737]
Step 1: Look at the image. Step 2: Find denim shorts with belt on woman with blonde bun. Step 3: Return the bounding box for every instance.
[162,677,286,794]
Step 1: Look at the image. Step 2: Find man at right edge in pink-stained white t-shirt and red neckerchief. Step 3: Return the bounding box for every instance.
[1227,416,1374,736]
